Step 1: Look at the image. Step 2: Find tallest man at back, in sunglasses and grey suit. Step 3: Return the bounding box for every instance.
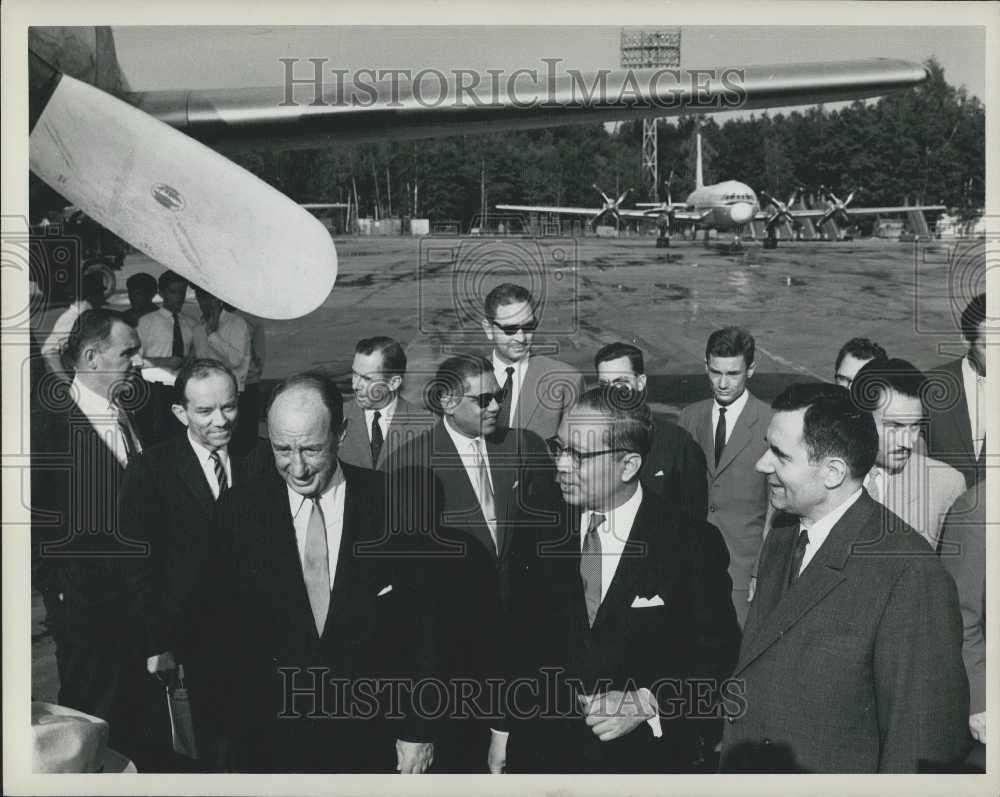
[483,282,584,440]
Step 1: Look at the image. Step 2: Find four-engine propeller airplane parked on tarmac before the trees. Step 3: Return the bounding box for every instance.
[496,128,945,249]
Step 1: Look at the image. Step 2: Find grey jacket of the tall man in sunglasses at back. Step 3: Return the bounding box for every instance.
[510,354,584,440]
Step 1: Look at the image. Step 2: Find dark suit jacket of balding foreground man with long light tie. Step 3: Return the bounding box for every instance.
[206,465,433,772]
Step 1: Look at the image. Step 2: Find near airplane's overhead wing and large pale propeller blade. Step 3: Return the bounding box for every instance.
[28,27,927,319]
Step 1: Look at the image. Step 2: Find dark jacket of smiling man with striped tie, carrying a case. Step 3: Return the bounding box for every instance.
[122,434,273,660]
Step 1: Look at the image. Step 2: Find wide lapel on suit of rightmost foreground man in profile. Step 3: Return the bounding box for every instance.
[733,492,877,676]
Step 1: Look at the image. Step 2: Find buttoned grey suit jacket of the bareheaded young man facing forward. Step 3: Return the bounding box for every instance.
[677,394,771,623]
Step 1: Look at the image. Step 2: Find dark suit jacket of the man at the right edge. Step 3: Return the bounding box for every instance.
[927,358,986,487]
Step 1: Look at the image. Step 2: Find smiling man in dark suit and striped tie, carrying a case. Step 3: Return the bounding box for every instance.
[122,359,271,769]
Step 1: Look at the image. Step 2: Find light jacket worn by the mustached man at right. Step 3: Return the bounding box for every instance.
[880,452,965,548]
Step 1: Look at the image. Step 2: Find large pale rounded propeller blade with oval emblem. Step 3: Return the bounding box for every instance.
[28,75,337,319]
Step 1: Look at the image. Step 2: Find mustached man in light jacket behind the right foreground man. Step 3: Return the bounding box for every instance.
[851,358,965,549]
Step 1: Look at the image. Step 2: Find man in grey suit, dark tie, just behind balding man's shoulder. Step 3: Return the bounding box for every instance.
[339,337,435,472]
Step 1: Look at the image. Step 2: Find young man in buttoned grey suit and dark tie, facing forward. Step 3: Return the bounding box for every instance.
[677,327,771,626]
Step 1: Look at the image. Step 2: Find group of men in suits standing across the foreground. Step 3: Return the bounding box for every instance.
[33,284,985,773]
